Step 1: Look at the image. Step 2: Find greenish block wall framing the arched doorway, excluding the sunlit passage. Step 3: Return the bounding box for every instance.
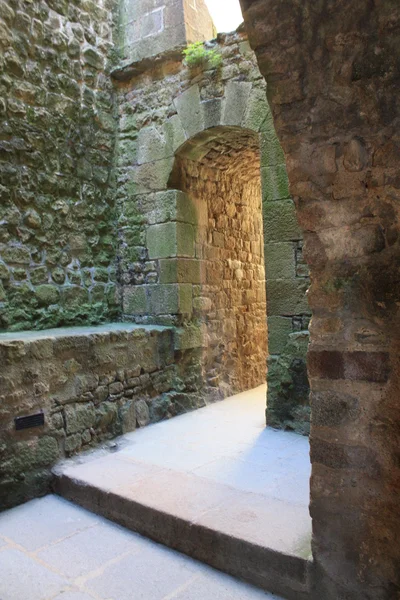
[113,32,309,424]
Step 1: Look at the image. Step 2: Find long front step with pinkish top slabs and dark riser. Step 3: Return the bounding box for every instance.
[54,453,310,600]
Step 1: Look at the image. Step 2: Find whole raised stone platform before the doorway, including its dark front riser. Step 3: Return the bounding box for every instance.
[55,386,311,600]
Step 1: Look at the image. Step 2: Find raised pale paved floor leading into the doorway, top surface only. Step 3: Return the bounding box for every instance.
[57,386,311,558]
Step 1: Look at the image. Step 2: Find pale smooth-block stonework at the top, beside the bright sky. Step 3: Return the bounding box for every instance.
[119,0,216,63]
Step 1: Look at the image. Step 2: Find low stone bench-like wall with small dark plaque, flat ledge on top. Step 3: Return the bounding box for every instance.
[0,324,204,510]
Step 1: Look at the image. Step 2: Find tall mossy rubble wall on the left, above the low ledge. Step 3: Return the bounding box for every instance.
[0,0,119,330]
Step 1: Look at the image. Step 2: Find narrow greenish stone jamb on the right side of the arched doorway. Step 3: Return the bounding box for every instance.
[261,108,310,434]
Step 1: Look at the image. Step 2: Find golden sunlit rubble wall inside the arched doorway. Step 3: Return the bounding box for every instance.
[175,138,267,395]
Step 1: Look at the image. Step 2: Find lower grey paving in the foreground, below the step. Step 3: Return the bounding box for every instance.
[0,496,284,600]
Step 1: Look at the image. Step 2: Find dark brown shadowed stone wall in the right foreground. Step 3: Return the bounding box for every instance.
[242,0,400,600]
